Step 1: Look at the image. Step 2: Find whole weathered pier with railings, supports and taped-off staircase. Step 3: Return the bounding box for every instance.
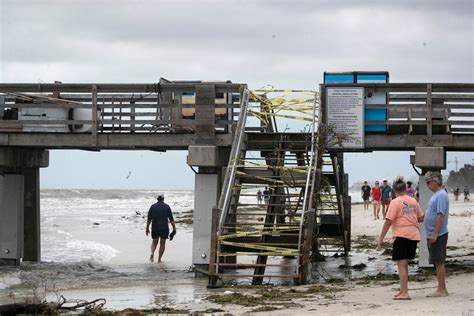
[0,78,474,286]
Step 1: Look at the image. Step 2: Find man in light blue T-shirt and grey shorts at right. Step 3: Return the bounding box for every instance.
[424,171,449,297]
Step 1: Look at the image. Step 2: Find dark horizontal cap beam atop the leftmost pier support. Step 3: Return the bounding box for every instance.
[0,147,49,168]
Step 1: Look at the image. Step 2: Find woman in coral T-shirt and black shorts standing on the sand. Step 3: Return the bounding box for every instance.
[377,177,423,300]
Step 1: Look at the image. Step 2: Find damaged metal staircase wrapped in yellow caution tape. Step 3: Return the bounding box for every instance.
[209,91,322,287]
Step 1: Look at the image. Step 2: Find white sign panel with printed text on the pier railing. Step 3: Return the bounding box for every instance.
[326,87,364,148]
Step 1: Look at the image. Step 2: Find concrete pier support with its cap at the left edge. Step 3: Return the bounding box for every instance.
[0,147,49,265]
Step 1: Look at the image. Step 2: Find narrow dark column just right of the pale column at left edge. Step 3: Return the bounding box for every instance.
[22,168,41,262]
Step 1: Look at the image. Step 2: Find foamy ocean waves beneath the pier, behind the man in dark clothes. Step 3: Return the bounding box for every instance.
[41,190,194,264]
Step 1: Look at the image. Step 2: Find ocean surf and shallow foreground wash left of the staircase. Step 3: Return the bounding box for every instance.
[0,190,197,309]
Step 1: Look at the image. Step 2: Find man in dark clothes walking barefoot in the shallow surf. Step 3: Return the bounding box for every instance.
[145,194,176,262]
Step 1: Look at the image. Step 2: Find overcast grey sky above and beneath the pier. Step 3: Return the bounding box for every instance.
[0,0,474,189]
